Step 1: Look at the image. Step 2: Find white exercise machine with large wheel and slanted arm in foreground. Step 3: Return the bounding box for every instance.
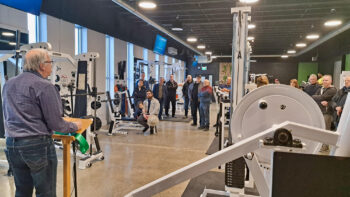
[126,85,350,197]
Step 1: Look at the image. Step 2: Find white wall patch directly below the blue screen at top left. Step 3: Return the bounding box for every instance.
[0,5,28,33]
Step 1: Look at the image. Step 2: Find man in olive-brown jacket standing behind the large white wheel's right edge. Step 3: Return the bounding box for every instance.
[312,75,337,152]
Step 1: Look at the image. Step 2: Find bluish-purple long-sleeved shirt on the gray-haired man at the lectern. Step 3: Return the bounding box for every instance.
[2,72,77,137]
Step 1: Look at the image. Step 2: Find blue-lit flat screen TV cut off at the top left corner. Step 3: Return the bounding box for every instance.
[0,0,42,15]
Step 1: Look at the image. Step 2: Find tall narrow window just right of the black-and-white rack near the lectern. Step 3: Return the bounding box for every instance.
[106,35,114,98]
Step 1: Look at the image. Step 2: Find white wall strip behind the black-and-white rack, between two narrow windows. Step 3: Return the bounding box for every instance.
[87,29,107,125]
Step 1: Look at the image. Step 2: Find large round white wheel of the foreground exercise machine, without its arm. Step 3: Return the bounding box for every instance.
[231,85,325,163]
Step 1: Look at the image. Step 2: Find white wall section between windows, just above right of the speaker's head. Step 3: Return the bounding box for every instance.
[47,15,75,56]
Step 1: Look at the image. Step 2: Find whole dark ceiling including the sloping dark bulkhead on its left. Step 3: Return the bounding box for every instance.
[42,0,350,60]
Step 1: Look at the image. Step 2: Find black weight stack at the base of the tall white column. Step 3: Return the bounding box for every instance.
[225,157,245,189]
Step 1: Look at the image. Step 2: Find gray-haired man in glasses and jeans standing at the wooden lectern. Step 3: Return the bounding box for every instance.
[3,49,81,197]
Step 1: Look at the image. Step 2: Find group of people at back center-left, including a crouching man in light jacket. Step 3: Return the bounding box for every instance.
[133,73,213,134]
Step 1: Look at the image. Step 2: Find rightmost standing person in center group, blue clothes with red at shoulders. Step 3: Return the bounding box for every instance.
[198,79,213,131]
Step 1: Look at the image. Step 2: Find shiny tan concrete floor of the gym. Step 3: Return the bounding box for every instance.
[0,105,216,197]
